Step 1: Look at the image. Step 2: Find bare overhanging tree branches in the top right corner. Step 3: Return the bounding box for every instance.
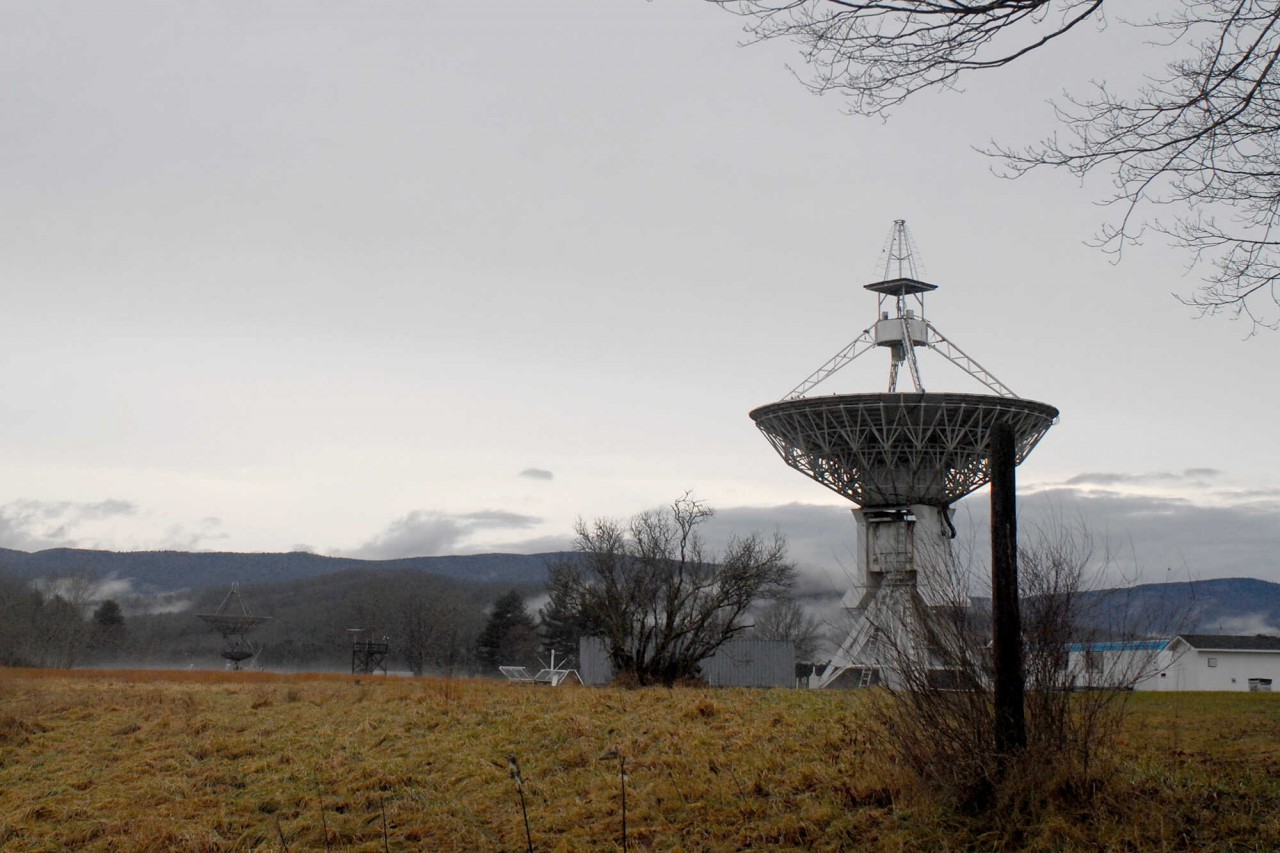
[708,0,1280,328]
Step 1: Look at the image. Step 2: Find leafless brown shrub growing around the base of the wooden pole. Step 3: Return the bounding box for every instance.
[876,525,1176,820]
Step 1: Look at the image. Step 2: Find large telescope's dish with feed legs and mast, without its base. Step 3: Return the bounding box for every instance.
[751,219,1057,507]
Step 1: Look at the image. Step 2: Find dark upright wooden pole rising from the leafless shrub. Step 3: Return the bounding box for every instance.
[989,424,1027,756]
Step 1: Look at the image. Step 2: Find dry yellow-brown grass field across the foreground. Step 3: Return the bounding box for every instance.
[0,670,1280,853]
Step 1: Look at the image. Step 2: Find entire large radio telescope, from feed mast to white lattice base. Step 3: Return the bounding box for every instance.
[751,219,1059,686]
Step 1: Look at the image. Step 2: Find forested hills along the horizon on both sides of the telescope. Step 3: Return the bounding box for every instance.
[0,551,1280,675]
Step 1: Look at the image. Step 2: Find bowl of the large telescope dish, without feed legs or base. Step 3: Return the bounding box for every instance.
[751,393,1057,506]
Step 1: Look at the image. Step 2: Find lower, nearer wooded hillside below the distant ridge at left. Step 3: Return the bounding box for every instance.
[0,560,543,674]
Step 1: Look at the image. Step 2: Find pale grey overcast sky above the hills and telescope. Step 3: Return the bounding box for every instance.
[0,0,1280,581]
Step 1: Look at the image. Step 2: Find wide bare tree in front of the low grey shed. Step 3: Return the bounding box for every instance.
[549,494,795,685]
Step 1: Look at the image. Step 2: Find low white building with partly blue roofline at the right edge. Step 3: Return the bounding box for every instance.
[1068,634,1280,692]
